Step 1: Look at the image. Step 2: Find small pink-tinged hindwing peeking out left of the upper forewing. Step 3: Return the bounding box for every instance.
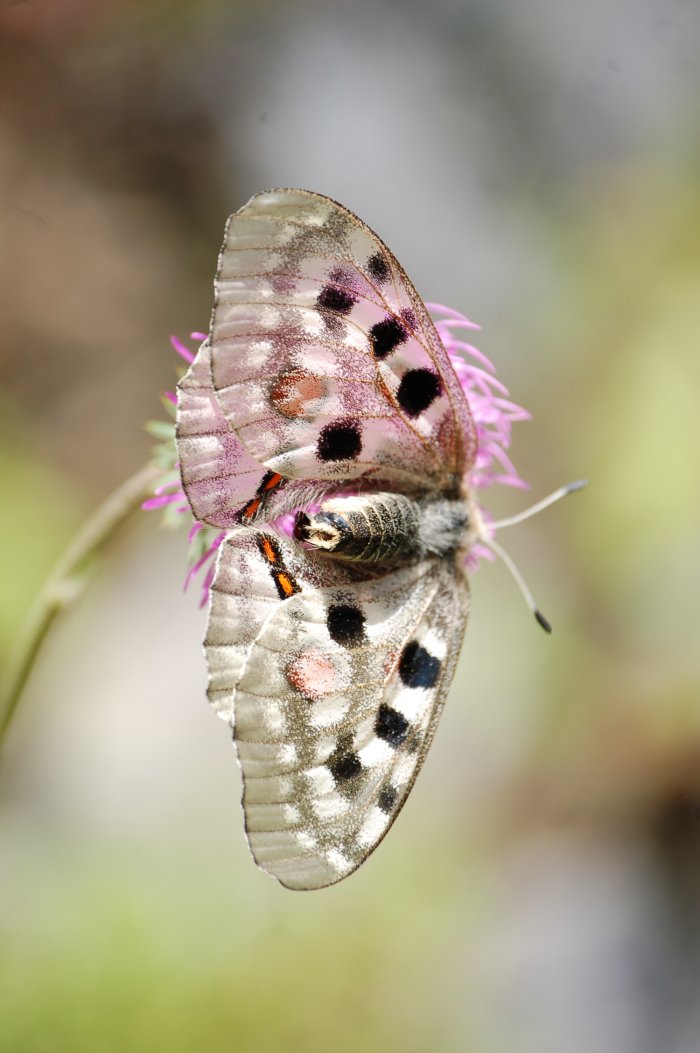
[175,340,271,530]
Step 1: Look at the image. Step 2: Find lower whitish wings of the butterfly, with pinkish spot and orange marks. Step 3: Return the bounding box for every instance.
[206,529,467,889]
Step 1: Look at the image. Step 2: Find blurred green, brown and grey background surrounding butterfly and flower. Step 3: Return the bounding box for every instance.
[0,0,700,1053]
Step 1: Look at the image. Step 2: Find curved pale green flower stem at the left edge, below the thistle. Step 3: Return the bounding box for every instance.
[0,464,162,746]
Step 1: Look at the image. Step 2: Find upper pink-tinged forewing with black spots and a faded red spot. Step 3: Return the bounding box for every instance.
[211,190,476,492]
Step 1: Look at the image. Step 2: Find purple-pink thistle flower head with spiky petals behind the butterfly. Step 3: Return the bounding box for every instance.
[142,303,531,607]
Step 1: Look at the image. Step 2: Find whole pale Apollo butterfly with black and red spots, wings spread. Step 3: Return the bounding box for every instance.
[177,190,517,889]
